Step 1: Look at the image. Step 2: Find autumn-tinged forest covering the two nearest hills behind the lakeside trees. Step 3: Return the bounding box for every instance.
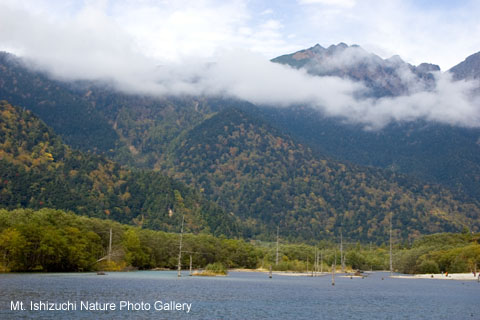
[0,98,480,243]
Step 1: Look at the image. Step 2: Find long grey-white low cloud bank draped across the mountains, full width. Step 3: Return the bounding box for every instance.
[0,5,480,129]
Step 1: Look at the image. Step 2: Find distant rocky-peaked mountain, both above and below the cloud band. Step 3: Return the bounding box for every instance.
[270,44,480,199]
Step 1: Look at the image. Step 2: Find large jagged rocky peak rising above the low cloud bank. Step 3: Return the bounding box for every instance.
[272,43,440,97]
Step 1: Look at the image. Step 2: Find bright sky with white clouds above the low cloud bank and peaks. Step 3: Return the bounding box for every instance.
[0,0,480,70]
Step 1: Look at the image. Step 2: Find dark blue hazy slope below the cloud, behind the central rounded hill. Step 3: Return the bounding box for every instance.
[261,107,480,199]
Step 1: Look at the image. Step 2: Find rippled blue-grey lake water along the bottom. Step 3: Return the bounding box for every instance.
[0,271,480,320]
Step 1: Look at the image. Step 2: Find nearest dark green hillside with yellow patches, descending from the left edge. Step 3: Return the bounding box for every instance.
[0,101,239,236]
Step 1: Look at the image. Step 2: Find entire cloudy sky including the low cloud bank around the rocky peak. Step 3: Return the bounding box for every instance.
[0,0,480,128]
